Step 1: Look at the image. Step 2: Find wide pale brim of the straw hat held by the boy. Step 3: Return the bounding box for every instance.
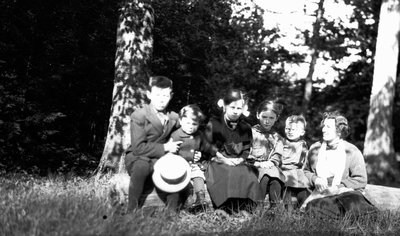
[152,156,191,193]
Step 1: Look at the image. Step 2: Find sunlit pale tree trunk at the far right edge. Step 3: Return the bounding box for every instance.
[364,0,400,185]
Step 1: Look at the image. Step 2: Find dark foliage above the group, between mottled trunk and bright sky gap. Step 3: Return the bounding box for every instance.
[150,0,291,115]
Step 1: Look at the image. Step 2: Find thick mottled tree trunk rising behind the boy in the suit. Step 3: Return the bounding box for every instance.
[96,1,154,176]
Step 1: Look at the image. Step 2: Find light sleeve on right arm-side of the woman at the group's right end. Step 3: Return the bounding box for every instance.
[341,147,367,189]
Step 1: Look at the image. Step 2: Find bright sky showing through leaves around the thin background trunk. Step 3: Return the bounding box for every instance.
[260,0,374,122]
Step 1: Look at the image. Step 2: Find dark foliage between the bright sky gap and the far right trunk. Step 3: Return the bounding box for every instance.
[306,0,381,150]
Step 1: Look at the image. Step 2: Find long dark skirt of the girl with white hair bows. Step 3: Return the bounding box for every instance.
[205,162,263,207]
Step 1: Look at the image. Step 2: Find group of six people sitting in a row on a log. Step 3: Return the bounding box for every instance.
[125,76,375,218]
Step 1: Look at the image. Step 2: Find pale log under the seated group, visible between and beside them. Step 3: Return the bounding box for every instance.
[109,174,400,211]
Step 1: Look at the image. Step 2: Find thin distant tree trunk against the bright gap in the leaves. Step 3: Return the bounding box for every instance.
[302,0,324,112]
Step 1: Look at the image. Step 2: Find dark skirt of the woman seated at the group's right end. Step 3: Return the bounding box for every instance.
[306,191,378,219]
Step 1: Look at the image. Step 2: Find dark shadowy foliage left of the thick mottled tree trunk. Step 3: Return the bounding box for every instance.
[0,0,117,173]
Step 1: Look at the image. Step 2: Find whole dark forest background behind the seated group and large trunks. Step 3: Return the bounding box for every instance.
[0,0,400,183]
